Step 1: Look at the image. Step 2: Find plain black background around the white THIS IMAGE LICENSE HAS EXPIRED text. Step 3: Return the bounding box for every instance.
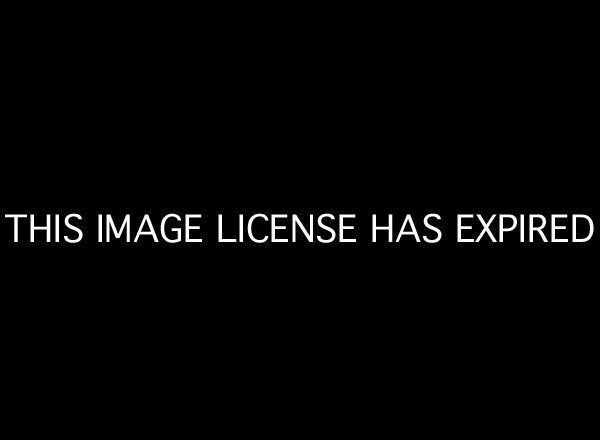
[1,5,598,433]
